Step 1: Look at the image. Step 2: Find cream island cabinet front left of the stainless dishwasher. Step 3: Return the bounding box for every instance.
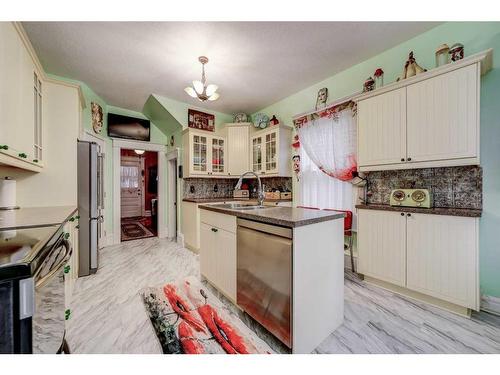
[200,210,236,302]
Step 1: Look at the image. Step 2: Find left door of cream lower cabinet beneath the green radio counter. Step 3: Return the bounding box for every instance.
[358,210,406,286]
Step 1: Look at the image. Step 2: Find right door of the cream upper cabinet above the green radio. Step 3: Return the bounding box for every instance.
[407,64,479,162]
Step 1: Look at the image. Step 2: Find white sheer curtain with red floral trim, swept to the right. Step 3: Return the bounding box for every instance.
[295,106,357,181]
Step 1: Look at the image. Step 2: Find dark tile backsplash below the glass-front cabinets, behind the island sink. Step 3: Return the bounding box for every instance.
[183,177,292,198]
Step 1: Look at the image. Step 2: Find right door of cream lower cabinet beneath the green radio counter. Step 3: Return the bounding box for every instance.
[406,214,479,310]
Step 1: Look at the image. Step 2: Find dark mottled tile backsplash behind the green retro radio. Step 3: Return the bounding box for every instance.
[367,166,483,209]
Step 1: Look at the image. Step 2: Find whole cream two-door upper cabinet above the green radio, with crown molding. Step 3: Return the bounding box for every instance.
[353,49,492,171]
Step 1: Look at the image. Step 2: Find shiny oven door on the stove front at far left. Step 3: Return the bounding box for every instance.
[32,234,72,354]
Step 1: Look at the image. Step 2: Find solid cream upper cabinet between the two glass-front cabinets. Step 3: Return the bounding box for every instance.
[226,123,250,176]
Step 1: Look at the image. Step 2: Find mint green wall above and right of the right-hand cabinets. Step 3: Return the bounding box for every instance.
[254,22,500,297]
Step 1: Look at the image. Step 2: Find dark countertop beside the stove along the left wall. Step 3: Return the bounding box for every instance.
[0,206,77,230]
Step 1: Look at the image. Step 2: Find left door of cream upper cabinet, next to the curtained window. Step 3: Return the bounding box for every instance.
[358,88,406,166]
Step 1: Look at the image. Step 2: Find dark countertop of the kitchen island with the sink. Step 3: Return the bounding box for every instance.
[200,205,345,228]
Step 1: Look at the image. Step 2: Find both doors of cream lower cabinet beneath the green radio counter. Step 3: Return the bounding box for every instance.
[358,209,479,310]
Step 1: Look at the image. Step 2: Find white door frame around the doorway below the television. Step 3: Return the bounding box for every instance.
[112,139,167,244]
